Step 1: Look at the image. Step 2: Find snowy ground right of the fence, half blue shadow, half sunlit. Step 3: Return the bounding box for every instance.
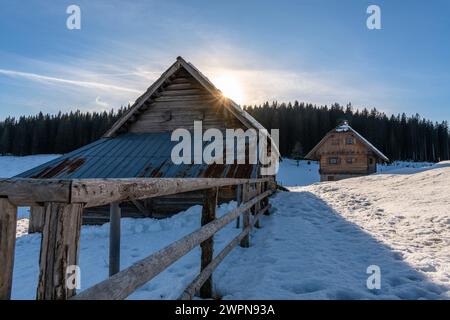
[216,162,450,299]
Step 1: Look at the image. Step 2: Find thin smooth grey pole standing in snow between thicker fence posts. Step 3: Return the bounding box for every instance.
[109,202,122,277]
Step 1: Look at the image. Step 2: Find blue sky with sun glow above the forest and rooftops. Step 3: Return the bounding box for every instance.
[0,0,450,121]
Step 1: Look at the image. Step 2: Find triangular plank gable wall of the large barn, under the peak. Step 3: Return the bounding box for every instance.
[128,69,244,133]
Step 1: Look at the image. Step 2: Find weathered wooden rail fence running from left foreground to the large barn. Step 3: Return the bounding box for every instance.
[0,177,275,300]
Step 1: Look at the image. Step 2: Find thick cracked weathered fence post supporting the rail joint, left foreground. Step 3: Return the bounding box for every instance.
[36,202,83,300]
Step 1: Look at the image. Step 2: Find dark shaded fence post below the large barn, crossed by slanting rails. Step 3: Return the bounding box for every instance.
[200,188,219,299]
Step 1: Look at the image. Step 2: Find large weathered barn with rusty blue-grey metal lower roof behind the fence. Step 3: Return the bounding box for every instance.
[18,57,279,231]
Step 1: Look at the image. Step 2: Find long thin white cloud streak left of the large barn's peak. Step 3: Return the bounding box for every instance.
[0,69,140,93]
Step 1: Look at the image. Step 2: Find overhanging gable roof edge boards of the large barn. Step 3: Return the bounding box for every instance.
[103,57,280,155]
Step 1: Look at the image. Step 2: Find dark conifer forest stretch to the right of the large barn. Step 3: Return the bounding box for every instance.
[244,101,450,162]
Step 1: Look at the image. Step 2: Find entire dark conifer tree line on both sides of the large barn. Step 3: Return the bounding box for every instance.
[0,101,450,162]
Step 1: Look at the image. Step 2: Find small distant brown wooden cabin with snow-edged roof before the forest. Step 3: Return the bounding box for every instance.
[305,121,389,181]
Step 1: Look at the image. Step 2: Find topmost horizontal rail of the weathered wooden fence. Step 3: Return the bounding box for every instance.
[0,178,270,208]
